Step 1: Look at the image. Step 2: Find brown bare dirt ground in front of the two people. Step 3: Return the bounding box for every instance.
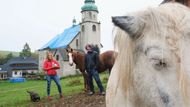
[30,93,105,107]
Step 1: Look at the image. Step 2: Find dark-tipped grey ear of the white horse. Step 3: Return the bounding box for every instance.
[112,16,145,38]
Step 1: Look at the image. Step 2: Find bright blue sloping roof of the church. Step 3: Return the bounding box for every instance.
[39,25,80,50]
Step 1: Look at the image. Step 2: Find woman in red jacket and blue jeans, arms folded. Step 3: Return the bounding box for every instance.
[43,52,63,100]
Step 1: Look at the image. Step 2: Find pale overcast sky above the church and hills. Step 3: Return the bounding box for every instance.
[0,0,162,51]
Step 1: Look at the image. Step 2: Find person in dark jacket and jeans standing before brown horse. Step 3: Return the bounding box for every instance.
[85,44,105,95]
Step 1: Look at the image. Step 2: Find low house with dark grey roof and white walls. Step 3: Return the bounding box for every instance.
[1,57,38,78]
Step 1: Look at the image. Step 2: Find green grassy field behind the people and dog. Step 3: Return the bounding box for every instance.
[0,74,108,107]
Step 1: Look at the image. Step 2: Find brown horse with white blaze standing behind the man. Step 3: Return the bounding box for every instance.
[67,48,116,90]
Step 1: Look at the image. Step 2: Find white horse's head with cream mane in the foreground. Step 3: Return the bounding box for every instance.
[106,3,190,107]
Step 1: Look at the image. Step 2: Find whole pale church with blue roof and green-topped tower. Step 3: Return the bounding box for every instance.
[39,0,101,76]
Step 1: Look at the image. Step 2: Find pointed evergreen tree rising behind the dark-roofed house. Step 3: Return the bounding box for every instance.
[19,43,32,57]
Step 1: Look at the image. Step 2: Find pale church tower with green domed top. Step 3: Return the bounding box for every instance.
[81,0,100,49]
